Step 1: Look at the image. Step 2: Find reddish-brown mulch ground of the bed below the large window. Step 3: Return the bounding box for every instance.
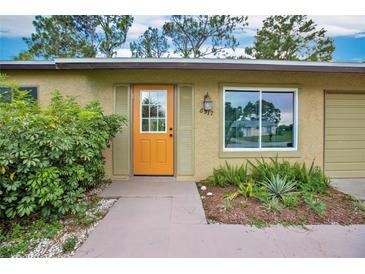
[197,182,365,227]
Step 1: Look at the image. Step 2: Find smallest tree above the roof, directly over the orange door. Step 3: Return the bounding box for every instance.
[130,27,168,58]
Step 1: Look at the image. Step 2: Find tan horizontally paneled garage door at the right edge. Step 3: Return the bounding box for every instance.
[324,92,365,178]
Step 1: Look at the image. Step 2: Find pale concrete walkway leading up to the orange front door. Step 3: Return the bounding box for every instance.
[75,177,365,257]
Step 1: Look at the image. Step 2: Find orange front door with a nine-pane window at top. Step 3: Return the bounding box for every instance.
[133,85,174,175]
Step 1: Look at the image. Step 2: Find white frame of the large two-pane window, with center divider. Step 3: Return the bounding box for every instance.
[222,86,298,152]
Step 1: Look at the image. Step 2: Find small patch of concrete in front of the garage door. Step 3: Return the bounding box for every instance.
[331,178,365,200]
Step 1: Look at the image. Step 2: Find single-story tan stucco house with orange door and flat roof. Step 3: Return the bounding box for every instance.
[0,58,365,180]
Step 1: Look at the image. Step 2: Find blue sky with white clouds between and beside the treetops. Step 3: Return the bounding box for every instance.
[0,15,365,62]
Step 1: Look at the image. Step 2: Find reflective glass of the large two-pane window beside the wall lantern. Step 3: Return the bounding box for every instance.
[224,90,294,148]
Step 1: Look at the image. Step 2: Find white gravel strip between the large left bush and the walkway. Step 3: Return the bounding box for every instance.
[22,199,117,258]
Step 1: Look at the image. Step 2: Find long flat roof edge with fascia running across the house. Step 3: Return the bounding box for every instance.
[0,58,365,73]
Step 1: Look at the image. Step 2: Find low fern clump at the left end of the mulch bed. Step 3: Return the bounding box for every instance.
[212,161,249,187]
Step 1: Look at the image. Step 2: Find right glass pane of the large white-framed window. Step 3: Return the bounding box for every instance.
[261,91,294,147]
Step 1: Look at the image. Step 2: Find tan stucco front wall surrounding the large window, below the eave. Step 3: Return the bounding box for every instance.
[5,70,365,179]
